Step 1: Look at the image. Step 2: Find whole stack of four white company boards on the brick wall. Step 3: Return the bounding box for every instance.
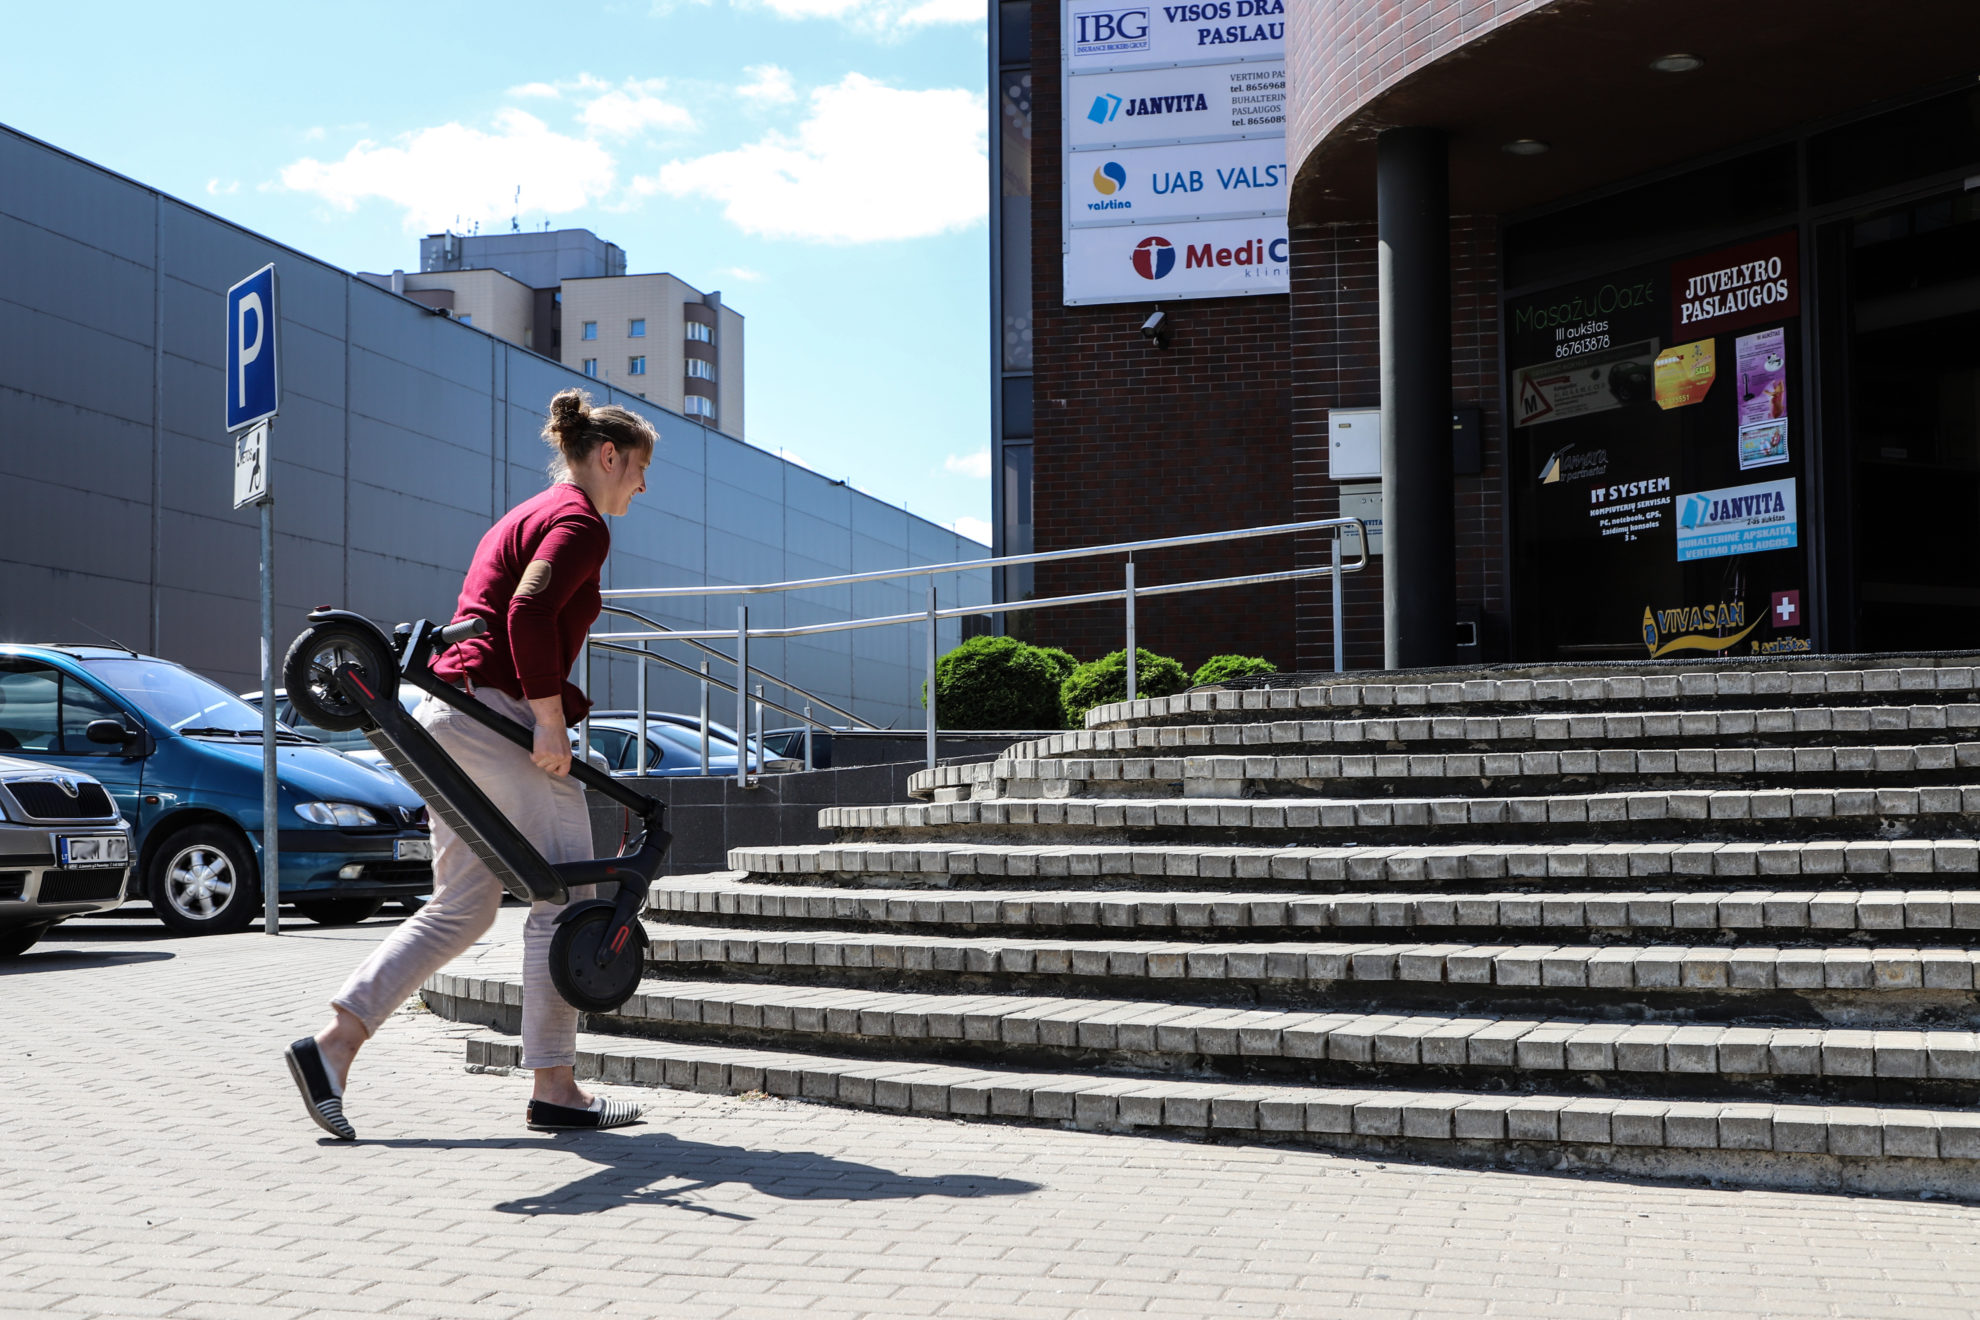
[1059,0,1301,307]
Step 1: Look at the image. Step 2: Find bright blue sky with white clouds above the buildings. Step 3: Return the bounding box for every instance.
[0,0,990,540]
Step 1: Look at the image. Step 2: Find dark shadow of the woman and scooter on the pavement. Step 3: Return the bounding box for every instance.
[360,1132,1040,1219]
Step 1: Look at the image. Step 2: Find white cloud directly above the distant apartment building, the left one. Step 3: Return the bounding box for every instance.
[281,109,614,234]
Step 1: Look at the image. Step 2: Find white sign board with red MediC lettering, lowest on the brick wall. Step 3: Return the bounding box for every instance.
[1065,214,1289,307]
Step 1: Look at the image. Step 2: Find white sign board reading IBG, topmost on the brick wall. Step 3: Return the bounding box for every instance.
[1063,0,1287,73]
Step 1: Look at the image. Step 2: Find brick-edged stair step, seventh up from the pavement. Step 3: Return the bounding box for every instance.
[909,740,1980,800]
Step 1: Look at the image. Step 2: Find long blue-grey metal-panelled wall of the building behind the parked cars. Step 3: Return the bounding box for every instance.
[0,131,988,726]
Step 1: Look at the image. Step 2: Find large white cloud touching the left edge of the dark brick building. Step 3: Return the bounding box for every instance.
[634,72,988,243]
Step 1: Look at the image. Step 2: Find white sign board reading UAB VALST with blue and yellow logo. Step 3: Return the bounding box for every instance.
[1065,139,1287,230]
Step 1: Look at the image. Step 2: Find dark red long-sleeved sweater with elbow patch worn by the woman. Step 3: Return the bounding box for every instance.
[434,481,612,724]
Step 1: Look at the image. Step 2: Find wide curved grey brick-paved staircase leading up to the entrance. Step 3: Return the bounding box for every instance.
[426,657,1980,1193]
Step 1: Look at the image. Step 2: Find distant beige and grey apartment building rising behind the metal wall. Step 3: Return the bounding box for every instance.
[362,230,743,439]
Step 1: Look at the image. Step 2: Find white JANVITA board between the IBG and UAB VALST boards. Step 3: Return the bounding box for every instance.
[1065,63,1285,154]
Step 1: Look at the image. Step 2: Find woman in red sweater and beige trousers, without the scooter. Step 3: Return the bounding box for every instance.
[287,390,655,1140]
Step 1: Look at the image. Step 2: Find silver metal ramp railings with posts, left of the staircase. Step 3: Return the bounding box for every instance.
[580,519,1368,786]
